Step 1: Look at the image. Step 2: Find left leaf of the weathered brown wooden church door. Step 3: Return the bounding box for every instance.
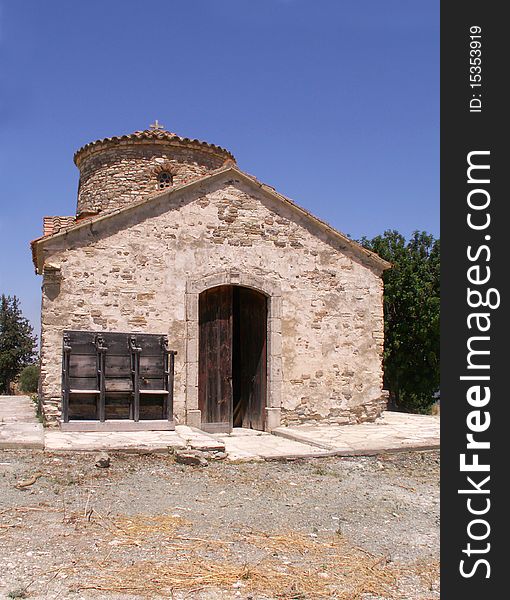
[198,285,232,432]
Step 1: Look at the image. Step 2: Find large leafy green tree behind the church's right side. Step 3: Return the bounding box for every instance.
[361,231,440,412]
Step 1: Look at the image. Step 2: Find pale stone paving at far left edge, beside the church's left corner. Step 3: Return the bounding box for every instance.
[0,396,44,449]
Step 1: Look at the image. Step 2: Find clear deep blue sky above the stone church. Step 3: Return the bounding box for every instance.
[0,0,439,331]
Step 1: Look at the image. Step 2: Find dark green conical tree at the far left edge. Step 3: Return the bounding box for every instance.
[0,294,36,394]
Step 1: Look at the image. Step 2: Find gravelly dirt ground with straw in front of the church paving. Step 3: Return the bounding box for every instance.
[0,450,439,600]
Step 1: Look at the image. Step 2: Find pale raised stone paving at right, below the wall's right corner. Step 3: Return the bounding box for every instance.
[273,411,440,455]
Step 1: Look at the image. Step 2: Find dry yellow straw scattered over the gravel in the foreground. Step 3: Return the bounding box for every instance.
[69,515,438,600]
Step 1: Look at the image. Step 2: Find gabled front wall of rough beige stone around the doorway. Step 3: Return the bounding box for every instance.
[41,176,385,424]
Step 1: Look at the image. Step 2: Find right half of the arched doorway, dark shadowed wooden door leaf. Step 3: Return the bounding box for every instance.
[234,287,267,431]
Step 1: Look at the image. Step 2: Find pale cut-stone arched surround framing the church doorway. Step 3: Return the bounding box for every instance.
[185,271,282,431]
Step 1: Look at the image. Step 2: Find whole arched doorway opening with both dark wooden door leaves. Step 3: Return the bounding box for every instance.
[198,285,267,432]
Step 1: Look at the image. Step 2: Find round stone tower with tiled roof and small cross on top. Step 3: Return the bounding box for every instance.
[74,121,235,219]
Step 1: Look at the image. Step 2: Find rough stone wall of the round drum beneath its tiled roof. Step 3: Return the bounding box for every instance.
[76,141,231,216]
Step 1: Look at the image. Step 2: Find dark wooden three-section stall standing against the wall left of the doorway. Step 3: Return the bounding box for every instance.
[62,331,176,426]
